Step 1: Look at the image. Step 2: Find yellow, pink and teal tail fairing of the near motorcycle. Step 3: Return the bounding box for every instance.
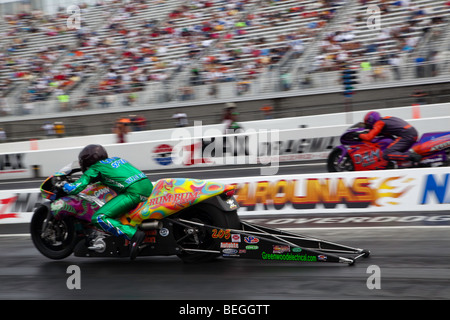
[121,178,235,226]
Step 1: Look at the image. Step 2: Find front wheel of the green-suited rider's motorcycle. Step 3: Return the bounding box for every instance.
[30,205,77,260]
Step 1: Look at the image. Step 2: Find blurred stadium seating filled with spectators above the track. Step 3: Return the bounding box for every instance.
[0,0,449,114]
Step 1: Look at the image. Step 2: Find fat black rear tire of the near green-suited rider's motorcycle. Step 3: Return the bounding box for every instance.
[174,204,241,263]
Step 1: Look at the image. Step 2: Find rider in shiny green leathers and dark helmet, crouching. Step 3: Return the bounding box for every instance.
[63,145,153,259]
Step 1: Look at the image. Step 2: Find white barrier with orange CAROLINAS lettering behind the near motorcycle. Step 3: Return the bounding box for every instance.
[0,167,450,223]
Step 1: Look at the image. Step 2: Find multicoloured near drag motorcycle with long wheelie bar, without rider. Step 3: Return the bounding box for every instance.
[30,163,369,265]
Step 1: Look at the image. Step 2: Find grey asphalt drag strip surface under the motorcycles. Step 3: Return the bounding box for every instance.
[0,163,450,302]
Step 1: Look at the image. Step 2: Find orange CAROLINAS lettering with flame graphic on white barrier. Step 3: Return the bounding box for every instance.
[235,176,415,211]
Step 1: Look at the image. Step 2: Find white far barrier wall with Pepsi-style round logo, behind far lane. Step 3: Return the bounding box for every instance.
[0,118,450,179]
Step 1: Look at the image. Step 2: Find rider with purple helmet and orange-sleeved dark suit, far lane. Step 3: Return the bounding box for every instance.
[359,111,421,167]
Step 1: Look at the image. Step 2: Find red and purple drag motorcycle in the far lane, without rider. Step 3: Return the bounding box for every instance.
[327,123,450,172]
